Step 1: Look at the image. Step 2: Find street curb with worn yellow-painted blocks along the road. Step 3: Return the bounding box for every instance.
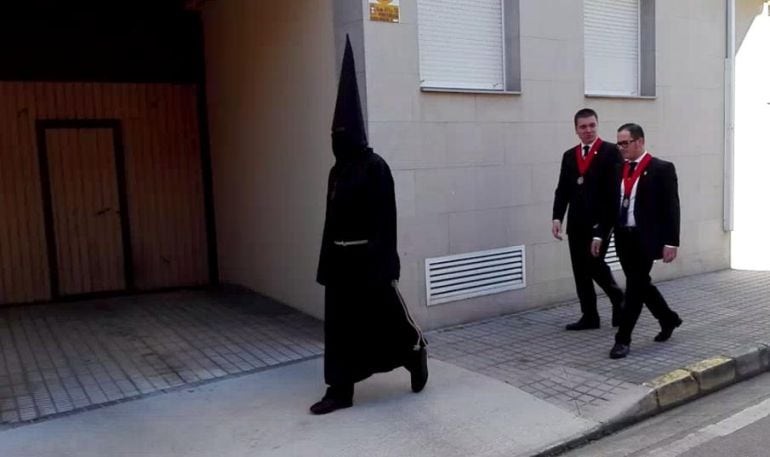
[532,343,770,457]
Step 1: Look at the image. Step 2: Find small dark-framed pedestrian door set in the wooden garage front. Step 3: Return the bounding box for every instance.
[38,121,131,296]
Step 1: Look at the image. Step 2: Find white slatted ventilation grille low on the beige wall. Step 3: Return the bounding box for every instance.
[425,245,526,306]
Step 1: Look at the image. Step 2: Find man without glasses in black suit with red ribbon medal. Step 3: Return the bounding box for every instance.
[551,108,623,330]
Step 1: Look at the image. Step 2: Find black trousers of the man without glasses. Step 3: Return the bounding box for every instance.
[567,230,623,322]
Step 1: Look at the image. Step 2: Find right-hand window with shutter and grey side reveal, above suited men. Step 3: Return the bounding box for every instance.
[583,0,655,96]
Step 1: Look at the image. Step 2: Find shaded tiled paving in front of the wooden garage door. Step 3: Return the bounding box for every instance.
[0,289,323,425]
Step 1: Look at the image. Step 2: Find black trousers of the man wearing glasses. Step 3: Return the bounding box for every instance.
[615,228,679,344]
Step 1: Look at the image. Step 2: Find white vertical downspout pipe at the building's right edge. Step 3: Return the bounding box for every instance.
[722,0,735,232]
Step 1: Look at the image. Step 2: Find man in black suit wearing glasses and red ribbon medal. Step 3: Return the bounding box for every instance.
[591,124,682,359]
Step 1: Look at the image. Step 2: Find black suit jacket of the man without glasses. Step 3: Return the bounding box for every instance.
[553,142,623,236]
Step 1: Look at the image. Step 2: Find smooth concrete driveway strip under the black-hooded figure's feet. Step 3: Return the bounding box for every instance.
[0,359,596,457]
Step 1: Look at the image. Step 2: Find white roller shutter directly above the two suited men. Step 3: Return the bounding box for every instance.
[583,0,639,95]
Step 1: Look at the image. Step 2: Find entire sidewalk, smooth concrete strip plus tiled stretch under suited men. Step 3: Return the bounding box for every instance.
[0,271,770,456]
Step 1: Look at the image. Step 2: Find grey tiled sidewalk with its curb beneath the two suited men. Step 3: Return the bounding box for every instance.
[433,271,770,456]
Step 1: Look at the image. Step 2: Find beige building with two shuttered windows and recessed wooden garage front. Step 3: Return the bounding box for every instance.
[0,0,766,328]
